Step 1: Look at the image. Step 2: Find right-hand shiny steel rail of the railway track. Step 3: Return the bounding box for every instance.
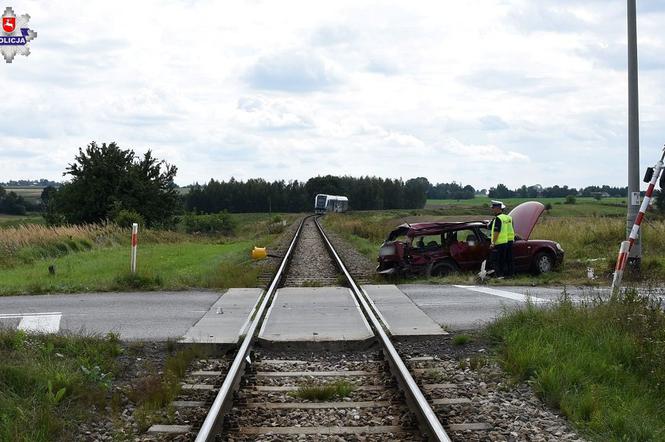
[315,218,451,442]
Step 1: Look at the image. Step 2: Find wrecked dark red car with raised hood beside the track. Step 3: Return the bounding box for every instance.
[377,201,564,276]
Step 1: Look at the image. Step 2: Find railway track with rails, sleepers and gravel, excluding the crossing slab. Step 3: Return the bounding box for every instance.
[174,217,450,441]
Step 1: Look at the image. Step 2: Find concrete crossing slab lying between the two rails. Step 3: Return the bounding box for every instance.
[259,287,374,343]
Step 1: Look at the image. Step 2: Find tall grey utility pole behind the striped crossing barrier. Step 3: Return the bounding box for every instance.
[626,0,642,271]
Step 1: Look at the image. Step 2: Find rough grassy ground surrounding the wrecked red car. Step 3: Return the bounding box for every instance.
[324,205,665,284]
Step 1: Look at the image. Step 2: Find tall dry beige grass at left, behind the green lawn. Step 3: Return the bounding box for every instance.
[0,223,185,267]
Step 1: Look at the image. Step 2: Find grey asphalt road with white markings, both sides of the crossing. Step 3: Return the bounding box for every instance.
[0,284,652,340]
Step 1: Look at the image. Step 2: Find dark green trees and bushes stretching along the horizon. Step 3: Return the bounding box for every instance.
[5,142,665,227]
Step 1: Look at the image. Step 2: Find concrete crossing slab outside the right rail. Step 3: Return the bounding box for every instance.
[362,284,447,336]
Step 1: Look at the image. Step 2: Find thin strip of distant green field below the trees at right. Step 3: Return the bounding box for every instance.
[425,196,626,216]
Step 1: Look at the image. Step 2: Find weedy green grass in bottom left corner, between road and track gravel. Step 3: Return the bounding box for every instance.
[0,330,201,442]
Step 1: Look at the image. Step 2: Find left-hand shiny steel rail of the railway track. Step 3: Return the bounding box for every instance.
[196,215,313,442]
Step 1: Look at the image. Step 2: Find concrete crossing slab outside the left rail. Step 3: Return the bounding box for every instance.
[180,288,263,344]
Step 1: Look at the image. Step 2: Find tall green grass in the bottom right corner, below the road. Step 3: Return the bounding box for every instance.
[488,294,665,441]
